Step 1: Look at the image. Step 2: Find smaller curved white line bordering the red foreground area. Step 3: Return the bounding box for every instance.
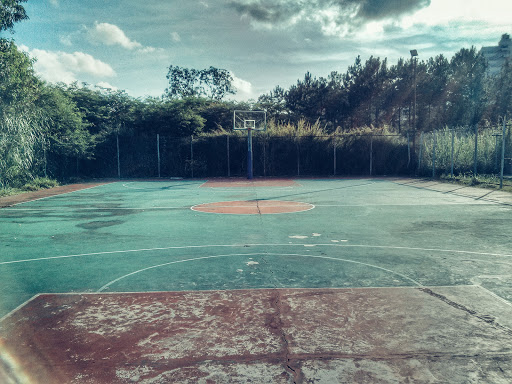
[97,252,423,293]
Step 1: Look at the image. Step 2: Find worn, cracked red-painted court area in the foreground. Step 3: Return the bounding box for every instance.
[0,286,512,383]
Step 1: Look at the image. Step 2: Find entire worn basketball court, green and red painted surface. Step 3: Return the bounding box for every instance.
[0,178,512,383]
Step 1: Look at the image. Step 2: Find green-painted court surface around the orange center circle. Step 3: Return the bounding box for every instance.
[0,179,512,382]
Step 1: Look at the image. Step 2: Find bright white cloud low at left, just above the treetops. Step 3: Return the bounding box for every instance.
[23,47,116,84]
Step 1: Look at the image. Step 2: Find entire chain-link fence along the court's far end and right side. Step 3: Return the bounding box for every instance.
[5,126,512,187]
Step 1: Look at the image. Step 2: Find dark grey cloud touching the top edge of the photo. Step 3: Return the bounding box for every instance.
[228,0,431,36]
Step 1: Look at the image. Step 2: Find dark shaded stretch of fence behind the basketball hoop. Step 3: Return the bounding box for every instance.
[74,134,414,178]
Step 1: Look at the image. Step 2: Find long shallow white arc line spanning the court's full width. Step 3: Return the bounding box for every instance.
[0,243,512,265]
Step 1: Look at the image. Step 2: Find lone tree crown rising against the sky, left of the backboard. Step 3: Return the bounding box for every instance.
[165,65,236,100]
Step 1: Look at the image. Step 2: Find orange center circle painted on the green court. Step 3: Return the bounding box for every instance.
[192,200,315,215]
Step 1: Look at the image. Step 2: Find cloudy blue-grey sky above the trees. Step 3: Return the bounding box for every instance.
[2,0,512,100]
